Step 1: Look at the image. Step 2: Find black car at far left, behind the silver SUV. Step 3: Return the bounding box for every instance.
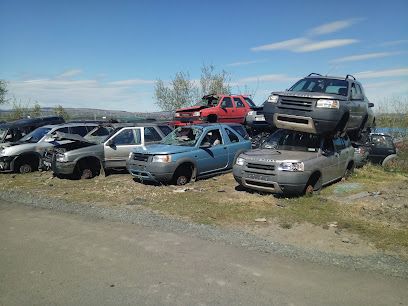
[0,116,65,143]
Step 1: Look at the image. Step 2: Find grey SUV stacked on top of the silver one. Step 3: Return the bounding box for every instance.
[263,73,375,141]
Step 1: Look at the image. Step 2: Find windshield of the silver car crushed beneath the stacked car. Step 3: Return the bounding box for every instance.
[262,130,320,152]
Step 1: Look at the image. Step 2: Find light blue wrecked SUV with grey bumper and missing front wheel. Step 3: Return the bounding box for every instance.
[127,124,251,185]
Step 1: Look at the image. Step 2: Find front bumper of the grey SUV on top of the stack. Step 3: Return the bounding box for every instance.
[264,103,346,134]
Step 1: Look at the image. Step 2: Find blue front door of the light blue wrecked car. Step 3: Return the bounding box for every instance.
[194,128,228,174]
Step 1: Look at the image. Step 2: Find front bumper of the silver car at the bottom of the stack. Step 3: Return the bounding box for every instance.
[233,165,310,194]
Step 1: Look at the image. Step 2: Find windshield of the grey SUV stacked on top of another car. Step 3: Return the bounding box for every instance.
[289,78,348,96]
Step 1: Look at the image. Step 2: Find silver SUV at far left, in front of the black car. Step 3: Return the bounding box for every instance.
[0,123,97,173]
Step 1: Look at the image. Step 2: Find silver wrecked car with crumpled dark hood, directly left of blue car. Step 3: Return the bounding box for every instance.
[51,123,172,179]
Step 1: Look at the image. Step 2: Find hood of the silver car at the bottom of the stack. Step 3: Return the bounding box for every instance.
[242,149,318,162]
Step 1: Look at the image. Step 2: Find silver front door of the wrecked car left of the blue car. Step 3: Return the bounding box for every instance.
[103,127,142,168]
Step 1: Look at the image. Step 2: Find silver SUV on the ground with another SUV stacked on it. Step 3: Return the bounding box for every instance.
[233,130,354,195]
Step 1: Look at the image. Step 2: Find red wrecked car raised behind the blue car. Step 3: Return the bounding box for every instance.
[172,95,256,126]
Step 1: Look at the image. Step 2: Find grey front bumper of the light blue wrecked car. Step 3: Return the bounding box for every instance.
[126,160,176,183]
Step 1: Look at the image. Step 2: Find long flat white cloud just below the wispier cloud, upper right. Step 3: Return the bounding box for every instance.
[251,38,358,52]
